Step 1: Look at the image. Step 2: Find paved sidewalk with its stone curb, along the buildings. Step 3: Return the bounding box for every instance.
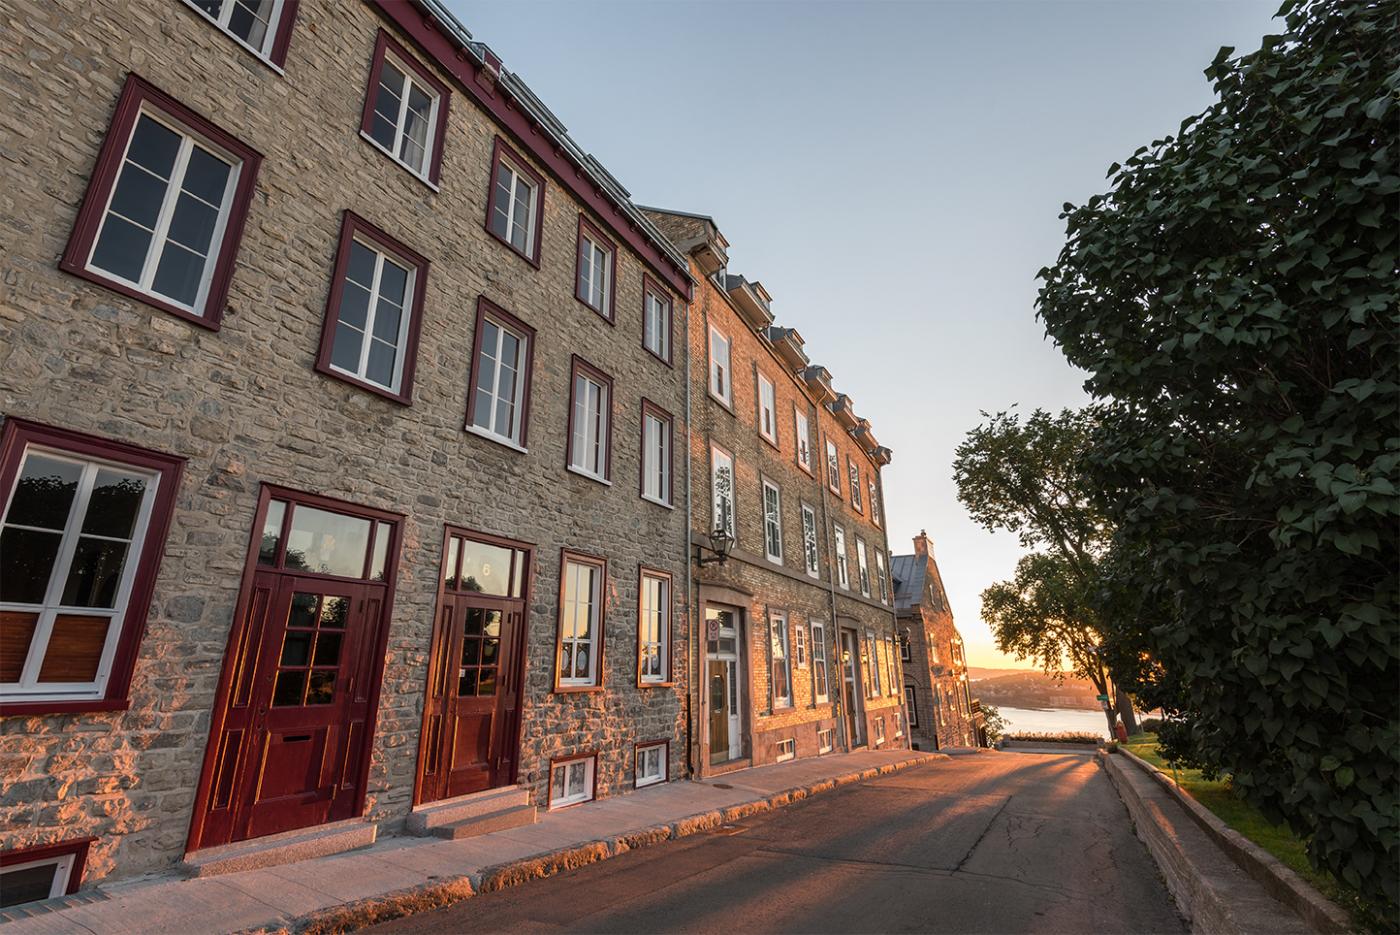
[0,750,942,935]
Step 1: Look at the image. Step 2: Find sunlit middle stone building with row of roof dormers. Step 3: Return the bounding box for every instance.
[647,209,909,775]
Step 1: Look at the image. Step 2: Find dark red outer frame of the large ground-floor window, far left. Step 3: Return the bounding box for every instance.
[0,419,185,715]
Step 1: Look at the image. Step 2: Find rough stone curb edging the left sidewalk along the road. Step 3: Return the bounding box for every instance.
[274,753,948,935]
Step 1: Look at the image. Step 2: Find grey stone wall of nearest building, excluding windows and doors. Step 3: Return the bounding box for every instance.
[0,0,690,882]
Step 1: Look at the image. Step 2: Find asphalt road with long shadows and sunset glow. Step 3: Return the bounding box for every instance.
[371,753,1186,934]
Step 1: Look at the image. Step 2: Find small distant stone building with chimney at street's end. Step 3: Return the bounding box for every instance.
[890,530,986,750]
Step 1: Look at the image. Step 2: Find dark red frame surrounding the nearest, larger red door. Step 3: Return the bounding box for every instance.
[185,481,405,852]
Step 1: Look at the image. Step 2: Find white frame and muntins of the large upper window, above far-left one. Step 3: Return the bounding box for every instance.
[83,101,244,318]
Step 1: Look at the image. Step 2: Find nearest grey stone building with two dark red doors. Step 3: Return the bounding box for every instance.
[0,0,697,899]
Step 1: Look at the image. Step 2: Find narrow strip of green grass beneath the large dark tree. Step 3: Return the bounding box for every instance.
[1123,733,1373,929]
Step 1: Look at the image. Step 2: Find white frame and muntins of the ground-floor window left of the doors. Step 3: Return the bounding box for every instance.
[0,445,160,703]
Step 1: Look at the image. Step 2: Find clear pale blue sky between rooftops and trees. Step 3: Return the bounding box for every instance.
[448,0,1278,666]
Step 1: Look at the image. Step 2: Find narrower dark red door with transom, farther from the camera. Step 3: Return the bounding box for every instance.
[416,526,531,802]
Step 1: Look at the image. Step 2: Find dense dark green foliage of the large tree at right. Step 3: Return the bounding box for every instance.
[1039,0,1400,906]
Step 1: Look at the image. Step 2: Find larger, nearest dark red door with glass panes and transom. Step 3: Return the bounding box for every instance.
[189,487,400,850]
